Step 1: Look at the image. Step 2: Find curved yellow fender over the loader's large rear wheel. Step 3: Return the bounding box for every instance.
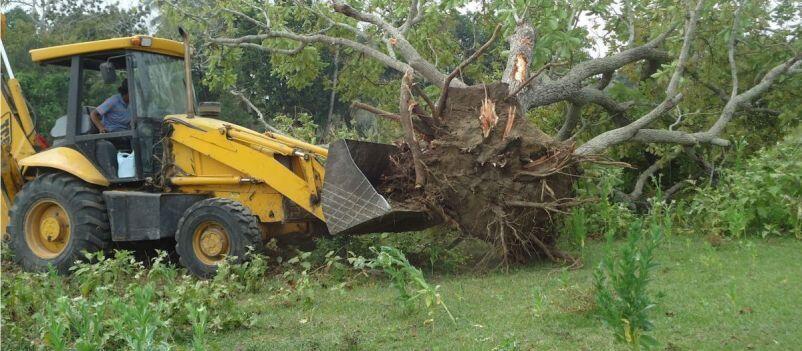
[19,147,109,186]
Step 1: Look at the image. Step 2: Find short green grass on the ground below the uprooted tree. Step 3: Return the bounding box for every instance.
[184,236,802,350]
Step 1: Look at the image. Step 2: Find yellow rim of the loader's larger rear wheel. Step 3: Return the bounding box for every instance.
[25,199,71,259]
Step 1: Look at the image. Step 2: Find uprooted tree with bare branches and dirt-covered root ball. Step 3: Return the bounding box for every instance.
[163,0,802,261]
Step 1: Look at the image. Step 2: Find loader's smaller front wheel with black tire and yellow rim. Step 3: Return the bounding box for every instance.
[175,198,265,278]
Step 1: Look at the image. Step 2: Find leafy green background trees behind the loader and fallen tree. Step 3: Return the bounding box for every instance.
[4,0,802,201]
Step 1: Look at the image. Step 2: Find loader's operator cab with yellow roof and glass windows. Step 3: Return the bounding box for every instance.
[31,36,187,184]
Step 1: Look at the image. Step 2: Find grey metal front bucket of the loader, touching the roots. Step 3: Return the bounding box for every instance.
[321,140,435,235]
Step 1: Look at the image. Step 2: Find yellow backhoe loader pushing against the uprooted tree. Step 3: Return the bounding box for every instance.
[0,26,432,277]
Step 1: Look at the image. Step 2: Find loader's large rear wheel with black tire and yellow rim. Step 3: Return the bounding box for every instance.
[8,173,111,274]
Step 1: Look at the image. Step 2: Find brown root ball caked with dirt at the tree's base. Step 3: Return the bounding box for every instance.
[379,83,579,262]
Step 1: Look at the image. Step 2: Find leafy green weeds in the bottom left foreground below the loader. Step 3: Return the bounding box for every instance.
[0,251,266,351]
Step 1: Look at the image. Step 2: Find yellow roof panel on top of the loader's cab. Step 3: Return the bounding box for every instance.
[31,35,184,62]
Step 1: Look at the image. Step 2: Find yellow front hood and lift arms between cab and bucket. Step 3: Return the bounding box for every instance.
[166,115,324,222]
